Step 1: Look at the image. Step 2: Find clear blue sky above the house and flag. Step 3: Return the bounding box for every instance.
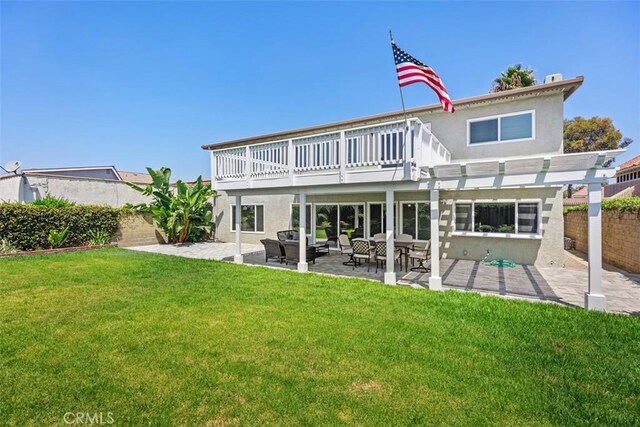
[0,1,640,179]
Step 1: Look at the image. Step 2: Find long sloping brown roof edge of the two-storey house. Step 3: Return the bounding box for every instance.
[202,76,584,150]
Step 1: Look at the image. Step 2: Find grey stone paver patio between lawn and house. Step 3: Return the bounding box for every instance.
[128,243,640,315]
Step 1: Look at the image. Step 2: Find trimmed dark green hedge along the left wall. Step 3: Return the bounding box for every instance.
[0,203,121,251]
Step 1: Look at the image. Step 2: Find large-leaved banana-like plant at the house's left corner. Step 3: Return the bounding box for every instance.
[127,168,217,243]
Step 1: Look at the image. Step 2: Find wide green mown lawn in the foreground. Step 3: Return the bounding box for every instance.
[0,249,640,426]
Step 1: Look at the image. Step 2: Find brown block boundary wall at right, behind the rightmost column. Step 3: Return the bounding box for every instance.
[564,211,640,273]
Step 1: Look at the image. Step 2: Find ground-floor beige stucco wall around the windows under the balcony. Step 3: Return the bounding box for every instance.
[214,188,564,266]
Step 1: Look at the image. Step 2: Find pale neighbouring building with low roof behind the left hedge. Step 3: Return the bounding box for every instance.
[0,166,151,207]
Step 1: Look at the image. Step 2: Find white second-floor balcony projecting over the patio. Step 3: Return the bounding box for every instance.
[211,118,451,190]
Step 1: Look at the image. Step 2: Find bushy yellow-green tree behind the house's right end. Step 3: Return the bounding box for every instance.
[563,116,633,198]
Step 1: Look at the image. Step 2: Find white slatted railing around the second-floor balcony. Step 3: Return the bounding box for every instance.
[212,119,451,186]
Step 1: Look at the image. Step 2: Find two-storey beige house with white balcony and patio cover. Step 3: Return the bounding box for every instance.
[203,77,623,308]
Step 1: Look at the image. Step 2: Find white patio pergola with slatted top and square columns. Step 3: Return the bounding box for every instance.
[226,150,624,311]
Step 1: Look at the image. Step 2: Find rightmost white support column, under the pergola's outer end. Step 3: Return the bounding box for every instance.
[584,184,606,311]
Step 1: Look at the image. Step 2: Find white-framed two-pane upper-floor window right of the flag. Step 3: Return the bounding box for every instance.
[467,110,535,145]
